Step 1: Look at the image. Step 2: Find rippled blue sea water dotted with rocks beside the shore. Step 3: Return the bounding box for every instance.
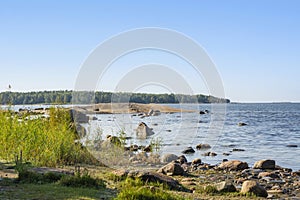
[85,103,300,170]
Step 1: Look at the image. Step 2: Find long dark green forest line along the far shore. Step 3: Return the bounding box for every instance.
[0,90,230,105]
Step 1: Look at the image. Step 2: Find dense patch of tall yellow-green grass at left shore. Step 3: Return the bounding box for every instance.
[0,108,93,167]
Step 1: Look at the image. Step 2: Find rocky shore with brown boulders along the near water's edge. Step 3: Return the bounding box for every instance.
[113,153,300,199]
